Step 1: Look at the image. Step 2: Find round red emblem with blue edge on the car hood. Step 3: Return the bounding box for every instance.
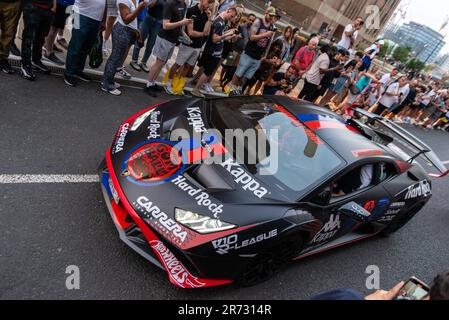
[123,141,183,183]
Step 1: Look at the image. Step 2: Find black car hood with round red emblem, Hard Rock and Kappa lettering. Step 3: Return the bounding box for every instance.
[110,99,289,225]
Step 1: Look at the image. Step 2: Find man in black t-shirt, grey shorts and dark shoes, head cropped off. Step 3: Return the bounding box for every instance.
[145,0,193,97]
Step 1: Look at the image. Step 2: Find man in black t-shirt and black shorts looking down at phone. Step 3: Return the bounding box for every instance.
[192,7,238,98]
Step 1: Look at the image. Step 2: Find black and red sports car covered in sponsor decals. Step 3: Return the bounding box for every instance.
[99,96,447,288]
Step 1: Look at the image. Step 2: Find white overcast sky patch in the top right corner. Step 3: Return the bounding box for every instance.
[402,0,449,53]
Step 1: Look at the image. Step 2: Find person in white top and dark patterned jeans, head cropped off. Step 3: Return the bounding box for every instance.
[101,0,148,95]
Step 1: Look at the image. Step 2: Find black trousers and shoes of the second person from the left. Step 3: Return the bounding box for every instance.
[21,0,56,80]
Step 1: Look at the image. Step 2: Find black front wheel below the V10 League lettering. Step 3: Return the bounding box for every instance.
[236,239,303,287]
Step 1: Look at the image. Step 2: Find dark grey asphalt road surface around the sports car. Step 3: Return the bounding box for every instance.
[0,74,449,299]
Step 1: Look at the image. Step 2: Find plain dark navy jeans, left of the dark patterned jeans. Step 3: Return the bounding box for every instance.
[64,14,101,76]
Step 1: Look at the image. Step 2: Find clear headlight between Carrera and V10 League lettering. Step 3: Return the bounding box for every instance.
[175,208,236,234]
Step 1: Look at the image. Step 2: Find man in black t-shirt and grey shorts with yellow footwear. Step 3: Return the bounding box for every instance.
[165,0,215,94]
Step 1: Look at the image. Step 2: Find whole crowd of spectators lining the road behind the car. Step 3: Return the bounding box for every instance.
[0,0,449,130]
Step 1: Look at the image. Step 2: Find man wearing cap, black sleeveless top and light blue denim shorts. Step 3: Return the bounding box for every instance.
[230,7,277,95]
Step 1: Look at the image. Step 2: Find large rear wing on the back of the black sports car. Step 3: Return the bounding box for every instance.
[352,108,449,178]
